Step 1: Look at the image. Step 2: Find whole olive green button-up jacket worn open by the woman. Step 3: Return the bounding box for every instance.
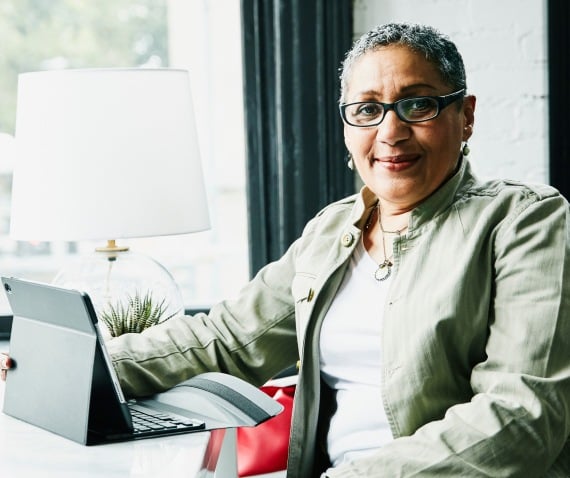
[109,161,570,478]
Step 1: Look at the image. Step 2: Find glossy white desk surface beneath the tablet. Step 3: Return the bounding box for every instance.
[0,340,237,478]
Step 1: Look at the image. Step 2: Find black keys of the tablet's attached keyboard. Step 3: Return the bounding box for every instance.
[129,403,205,435]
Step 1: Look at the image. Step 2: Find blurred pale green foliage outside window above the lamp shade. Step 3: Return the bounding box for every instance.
[0,0,168,134]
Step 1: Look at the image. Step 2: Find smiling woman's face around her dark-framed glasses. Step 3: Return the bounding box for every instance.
[344,45,475,212]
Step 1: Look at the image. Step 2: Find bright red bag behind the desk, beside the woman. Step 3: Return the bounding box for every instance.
[237,381,295,478]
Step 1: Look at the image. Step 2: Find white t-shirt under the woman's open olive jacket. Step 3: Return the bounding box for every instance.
[320,241,392,466]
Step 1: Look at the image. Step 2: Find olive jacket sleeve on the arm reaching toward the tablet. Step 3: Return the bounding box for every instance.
[107,243,298,396]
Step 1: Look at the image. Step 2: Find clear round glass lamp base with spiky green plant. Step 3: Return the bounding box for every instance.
[53,250,184,338]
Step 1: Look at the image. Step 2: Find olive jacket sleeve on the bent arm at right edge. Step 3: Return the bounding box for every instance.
[327,190,570,478]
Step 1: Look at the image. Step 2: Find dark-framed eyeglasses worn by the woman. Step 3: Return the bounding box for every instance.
[339,89,465,128]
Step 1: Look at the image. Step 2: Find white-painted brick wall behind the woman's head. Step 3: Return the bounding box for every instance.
[354,0,548,182]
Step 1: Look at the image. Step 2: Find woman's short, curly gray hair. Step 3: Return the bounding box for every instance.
[340,23,467,102]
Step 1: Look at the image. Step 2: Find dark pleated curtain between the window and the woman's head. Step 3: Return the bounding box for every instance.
[237,0,354,275]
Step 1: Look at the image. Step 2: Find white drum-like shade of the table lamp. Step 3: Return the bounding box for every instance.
[10,69,210,240]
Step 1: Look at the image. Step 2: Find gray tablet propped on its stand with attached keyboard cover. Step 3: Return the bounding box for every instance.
[2,277,283,445]
